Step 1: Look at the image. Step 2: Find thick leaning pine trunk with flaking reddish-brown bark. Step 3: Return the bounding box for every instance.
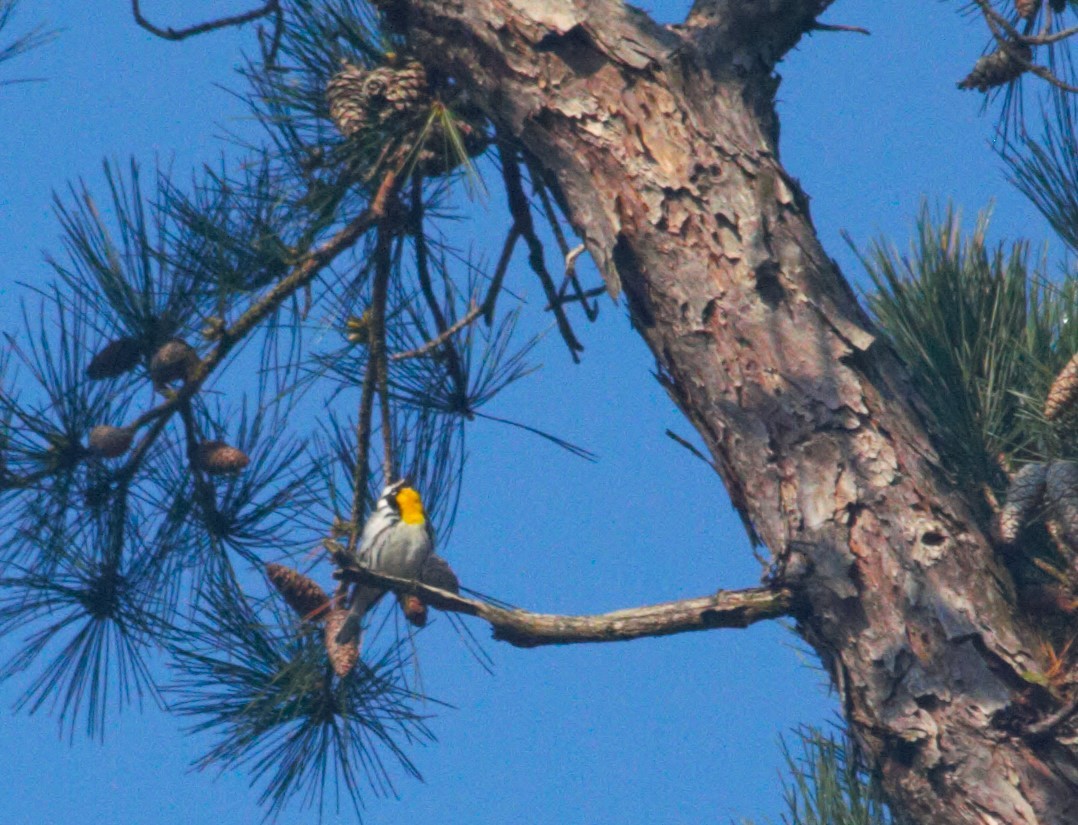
[392,0,1078,825]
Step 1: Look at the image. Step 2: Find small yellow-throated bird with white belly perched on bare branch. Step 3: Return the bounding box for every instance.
[336,479,434,646]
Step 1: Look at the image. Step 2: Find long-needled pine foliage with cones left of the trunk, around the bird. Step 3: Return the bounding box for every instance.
[0,0,596,813]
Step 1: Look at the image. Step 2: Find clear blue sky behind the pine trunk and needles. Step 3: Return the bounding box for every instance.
[0,0,1060,825]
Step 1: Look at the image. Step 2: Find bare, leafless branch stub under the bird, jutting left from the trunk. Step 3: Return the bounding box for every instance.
[334,567,793,647]
